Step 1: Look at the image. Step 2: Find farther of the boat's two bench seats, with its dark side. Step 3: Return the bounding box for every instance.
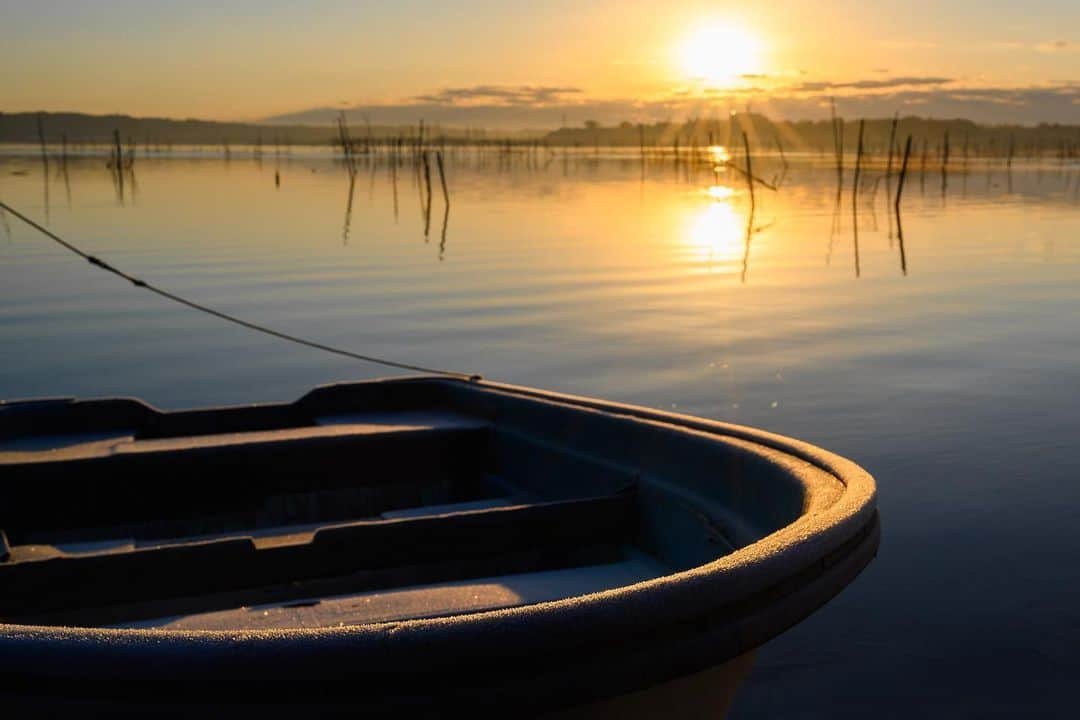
[0,417,492,544]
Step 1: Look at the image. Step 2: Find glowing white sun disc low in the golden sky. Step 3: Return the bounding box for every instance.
[680,23,761,85]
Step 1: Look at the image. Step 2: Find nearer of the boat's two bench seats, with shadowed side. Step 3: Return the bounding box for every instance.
[0,488,636,624]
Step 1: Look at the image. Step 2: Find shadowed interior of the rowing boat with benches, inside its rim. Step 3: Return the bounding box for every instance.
[0,379,825,630]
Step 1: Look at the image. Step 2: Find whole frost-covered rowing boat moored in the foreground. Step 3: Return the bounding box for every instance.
[0,377,879,715]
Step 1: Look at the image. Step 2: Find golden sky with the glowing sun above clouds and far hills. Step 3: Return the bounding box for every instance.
[0,0,1080,121]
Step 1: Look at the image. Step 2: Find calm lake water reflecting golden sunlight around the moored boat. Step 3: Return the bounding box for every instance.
[0,150,1080,718]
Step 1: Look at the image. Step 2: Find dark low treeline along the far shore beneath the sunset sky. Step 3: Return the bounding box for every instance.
[0,112,1080,158]
